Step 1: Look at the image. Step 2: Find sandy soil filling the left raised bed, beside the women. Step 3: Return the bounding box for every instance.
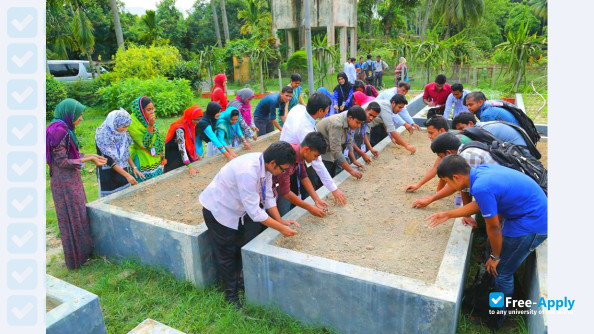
[109,134,279,225]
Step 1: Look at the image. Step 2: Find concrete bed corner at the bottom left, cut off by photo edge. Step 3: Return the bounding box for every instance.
[45,275,107,334]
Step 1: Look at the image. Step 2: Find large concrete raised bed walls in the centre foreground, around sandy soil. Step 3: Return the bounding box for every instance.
[242,127,472,333]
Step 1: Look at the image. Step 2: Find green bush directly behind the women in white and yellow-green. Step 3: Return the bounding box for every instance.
[98,77,193,117]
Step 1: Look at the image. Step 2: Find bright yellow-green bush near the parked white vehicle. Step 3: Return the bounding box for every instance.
[114,45,182,79]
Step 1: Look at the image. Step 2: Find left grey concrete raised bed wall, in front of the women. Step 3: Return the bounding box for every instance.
[87,132,279,286]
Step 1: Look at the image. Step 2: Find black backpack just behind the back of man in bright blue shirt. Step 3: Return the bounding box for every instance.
[460,141,548,195]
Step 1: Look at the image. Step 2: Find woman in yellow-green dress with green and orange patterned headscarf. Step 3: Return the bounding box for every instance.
[128,96,167,182]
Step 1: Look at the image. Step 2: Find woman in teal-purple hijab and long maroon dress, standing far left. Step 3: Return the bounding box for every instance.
[45,99,107,269]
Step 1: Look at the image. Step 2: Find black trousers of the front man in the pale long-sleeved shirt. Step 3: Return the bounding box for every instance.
[202,208,265,302]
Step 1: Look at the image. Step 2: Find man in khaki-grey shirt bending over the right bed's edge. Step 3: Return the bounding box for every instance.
[316,106,367,179]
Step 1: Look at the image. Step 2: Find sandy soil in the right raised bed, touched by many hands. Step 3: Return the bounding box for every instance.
[277,133,454,282]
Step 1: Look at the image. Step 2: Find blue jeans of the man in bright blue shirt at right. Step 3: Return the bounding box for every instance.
[495,234,547,298]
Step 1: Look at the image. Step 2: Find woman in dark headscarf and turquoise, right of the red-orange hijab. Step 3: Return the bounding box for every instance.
[196,102,237,160]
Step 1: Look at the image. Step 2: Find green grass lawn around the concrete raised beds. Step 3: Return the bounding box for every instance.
[46,81,526,333]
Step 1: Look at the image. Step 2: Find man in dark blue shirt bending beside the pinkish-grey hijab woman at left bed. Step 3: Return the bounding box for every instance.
[254,86,293,137]
